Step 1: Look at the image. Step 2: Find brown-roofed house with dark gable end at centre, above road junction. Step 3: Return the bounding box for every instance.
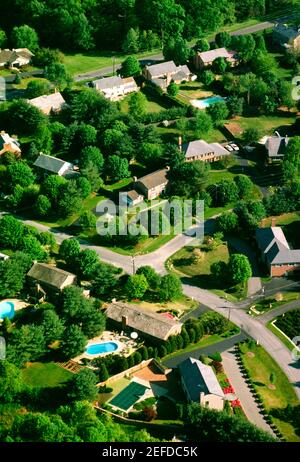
[134,167,170,200]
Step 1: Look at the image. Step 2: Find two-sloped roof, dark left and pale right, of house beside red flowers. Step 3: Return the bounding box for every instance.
[179,358,224,402]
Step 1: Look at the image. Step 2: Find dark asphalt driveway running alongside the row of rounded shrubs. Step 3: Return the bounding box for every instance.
[163,332,248,368]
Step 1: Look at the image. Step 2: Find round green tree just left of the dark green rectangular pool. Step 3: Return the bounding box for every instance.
[68,369,98,401]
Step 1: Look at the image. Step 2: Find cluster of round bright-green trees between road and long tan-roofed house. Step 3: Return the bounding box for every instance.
[125,266,182,302]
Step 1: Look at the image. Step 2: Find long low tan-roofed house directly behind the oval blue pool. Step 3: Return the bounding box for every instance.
[106,302,182,341]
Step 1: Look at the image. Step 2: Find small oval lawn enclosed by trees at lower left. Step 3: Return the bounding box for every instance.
[22,363,74,388]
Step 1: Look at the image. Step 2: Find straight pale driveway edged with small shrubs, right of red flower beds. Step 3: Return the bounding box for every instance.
[222,349,276,438]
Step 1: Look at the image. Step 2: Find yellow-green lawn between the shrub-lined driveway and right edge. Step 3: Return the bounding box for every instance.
[242,345,300,442]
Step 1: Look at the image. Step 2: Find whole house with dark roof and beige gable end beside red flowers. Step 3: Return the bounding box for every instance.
[178,357,224,411]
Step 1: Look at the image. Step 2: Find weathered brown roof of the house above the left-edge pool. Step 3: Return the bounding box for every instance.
[27,263,76,290]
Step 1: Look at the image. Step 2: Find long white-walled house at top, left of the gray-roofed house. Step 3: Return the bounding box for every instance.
[92,76,139,101]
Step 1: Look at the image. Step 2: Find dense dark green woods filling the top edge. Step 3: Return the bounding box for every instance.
[0,0,291,52]
